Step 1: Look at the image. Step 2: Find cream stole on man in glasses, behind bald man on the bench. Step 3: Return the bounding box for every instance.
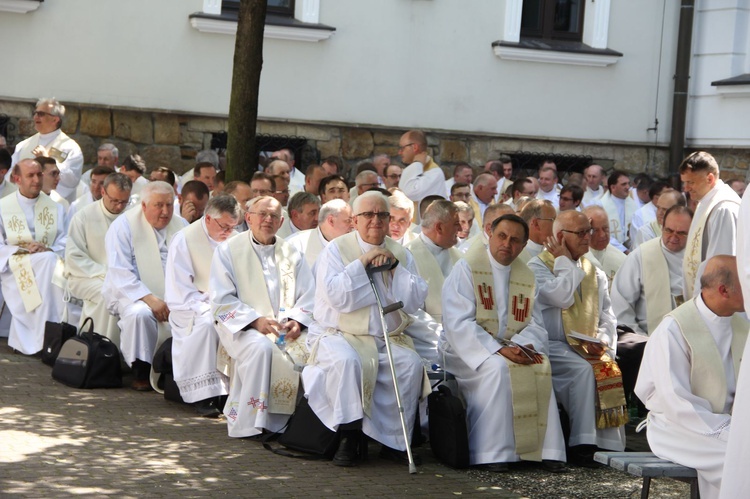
[640,238,674,335]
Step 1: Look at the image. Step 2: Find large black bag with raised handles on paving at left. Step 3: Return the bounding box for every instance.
[52,318,122,388]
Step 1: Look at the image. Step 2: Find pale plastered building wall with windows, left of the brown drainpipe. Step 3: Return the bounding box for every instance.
[0,0,679,144]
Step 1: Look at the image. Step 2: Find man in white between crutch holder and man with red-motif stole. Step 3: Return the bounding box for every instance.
[406,200,461,366]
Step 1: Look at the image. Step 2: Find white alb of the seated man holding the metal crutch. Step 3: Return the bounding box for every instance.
[302,232,428,450]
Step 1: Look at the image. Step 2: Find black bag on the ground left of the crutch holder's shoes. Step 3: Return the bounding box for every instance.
[278,397,339,459]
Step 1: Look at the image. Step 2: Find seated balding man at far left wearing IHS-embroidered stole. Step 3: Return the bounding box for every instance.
[0,159,66,355]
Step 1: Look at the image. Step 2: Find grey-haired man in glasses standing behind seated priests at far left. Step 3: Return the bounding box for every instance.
[13,98,83,203]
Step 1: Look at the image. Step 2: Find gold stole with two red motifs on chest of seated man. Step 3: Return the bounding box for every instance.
[466,245,552,461]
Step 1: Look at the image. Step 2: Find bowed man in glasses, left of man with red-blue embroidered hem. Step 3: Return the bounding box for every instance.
[164,195,242,417]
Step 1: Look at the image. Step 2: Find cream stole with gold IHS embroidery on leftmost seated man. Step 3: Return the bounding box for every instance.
[0,192,58,312]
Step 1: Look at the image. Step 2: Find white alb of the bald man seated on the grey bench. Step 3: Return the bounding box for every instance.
[635,297,736,499]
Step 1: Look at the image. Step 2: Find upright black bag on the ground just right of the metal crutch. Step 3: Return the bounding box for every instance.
[427,385,469,468]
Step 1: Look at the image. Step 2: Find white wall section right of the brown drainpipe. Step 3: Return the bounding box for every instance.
[686,0,750,147]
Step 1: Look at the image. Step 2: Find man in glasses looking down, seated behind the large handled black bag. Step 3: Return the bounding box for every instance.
[65,174,133,346]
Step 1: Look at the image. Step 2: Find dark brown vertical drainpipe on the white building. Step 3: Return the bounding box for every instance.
[669,0,695,186]
